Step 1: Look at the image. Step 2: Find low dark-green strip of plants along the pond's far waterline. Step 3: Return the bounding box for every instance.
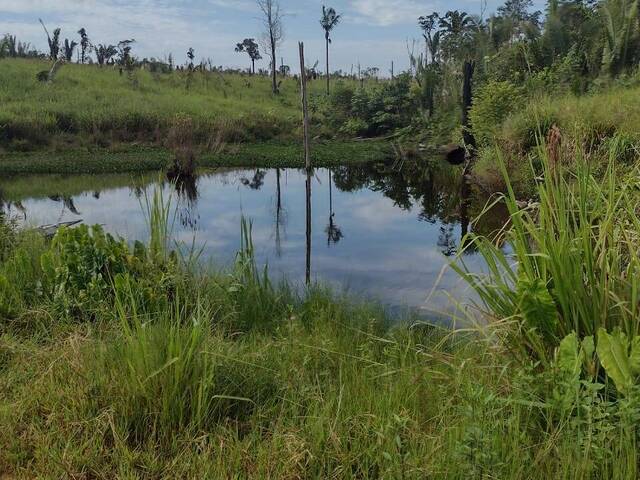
[0,140,393,175]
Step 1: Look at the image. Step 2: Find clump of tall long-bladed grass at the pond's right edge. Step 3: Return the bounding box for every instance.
[456,145,640,364]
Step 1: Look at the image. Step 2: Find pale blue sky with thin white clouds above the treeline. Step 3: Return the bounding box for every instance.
[0,0,541,71]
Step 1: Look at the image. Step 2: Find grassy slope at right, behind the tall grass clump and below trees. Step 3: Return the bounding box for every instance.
[475,86,640,196]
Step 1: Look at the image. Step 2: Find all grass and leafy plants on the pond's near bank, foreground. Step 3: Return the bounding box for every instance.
[0,147,640,479]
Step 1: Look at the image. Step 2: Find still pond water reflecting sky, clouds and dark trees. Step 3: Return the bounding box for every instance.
[0,165,504,312]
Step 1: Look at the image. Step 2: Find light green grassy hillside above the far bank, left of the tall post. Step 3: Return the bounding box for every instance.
[0,59,364,151]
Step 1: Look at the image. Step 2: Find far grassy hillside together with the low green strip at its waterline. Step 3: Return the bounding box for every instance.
[0,60,387,175]
